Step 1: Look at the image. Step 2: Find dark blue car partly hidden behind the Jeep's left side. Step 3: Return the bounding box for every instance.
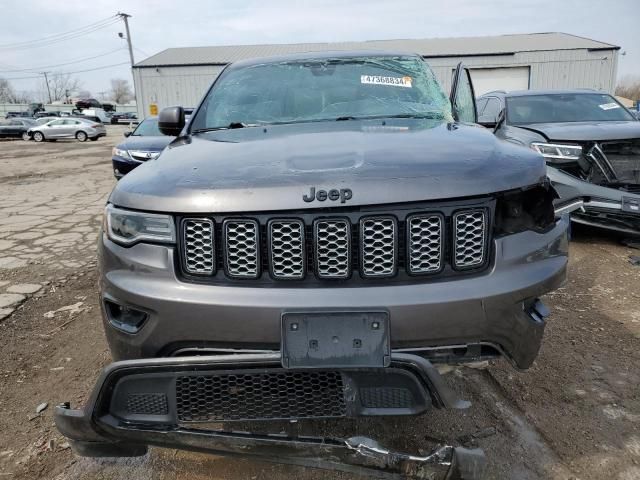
[111,117,175,178]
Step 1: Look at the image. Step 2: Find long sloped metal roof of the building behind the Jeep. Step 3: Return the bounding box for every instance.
[135,32,620,67]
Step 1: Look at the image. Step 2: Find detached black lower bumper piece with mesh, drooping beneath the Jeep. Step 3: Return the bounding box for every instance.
[55,354,485,479]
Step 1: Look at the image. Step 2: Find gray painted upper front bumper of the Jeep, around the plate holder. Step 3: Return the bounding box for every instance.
[99,216,569,369]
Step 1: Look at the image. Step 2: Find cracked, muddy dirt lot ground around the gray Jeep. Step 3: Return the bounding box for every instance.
[0,127,640,480]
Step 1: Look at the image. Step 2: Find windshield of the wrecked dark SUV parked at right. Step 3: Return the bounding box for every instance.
[507,93,634,125]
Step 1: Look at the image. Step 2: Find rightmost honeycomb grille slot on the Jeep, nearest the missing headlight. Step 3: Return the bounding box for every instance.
[453,209,487,269]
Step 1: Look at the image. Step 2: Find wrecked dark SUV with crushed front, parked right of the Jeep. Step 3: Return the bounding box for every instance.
[478,90,640,235]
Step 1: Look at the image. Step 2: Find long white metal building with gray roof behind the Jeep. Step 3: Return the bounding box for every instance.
[133,33,620,116]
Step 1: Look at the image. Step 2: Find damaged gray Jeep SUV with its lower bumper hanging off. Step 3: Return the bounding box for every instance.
[56,52,568,478]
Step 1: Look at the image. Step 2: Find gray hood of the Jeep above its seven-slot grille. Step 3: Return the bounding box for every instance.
[110,120,546,213]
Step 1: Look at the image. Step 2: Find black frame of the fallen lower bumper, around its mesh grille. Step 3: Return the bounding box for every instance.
[54,354,485,479]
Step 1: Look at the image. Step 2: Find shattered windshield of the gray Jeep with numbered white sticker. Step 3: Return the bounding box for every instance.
[192,56,452,132]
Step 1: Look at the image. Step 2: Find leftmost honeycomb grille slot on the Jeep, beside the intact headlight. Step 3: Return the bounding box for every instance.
[182,218,216,275]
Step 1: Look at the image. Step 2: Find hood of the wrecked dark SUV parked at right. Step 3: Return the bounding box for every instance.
[515,121,640,142]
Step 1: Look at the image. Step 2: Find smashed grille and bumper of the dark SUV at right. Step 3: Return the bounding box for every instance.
[547,139,640,235]
